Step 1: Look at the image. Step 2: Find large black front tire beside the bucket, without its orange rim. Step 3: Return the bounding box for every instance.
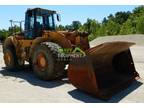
[32,42,65,80]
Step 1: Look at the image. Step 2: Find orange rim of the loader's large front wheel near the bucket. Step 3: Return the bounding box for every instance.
[37,53,48,69]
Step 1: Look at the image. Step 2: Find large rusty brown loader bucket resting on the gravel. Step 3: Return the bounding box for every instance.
[68,42,139,99]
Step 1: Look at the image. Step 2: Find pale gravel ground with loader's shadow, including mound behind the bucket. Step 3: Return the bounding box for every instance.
[0,35,144,103]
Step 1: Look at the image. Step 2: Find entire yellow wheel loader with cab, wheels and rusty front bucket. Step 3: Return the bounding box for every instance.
[3,8,139,99]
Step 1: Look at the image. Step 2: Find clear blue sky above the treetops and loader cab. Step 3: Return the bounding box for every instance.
[0,5,137,29]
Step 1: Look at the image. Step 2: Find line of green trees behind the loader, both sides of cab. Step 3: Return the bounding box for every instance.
[0,6,144,41]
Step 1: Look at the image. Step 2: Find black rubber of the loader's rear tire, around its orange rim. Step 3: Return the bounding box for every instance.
[3,46,24,71]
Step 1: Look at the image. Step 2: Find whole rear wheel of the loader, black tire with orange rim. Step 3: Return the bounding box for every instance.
[3,46,24,71]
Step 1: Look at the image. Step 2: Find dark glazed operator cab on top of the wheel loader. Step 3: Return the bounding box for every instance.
[25,8,60,39]
